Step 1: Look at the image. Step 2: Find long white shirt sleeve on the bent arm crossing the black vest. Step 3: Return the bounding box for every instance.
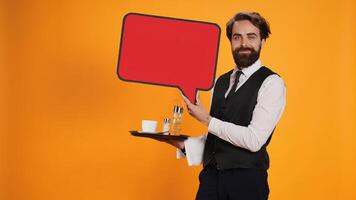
[208,75,286,152]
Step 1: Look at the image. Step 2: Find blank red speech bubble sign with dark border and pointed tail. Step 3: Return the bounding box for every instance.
[118,13,220,102]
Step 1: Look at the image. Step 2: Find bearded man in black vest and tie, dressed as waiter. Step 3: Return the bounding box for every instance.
[165,12,286,200]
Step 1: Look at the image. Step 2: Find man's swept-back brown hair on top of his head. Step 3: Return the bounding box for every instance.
[226,12,271,41]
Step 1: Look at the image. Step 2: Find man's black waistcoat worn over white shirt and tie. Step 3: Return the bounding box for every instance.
[203,67,275,170]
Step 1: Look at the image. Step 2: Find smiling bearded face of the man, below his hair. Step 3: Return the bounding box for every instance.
[231,20,265,69]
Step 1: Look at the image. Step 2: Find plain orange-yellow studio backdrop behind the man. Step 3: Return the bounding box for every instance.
[0,0,356,200]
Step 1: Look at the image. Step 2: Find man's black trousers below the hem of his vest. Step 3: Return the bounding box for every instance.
[196,166,269,200]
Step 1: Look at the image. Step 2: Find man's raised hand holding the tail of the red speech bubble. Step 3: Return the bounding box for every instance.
[182,94,211,126]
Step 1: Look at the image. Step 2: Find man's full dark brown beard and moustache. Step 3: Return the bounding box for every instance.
[232,45,261,69]
